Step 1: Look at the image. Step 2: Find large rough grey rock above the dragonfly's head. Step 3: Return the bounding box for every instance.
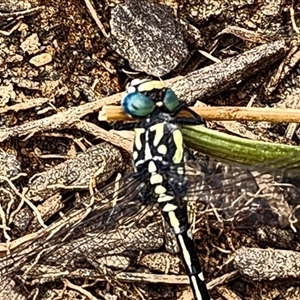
[109,0,189,77]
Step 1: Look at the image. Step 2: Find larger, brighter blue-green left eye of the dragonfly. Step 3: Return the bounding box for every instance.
[121,92,155,117]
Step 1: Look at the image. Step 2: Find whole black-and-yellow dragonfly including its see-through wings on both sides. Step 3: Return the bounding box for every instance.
[0,80,299,300]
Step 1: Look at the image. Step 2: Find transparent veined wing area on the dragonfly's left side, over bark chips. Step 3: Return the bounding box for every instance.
[0,175,163,292]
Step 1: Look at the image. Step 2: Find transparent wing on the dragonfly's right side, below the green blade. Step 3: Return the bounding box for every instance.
[171,158,300,230]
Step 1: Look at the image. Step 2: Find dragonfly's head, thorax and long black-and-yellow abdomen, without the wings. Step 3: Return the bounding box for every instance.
[121,79,210,300]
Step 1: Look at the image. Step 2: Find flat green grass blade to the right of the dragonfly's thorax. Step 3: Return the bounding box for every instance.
[182,126,300,173]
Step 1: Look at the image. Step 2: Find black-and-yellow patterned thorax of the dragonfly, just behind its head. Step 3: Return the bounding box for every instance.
[133,112,186,206]
